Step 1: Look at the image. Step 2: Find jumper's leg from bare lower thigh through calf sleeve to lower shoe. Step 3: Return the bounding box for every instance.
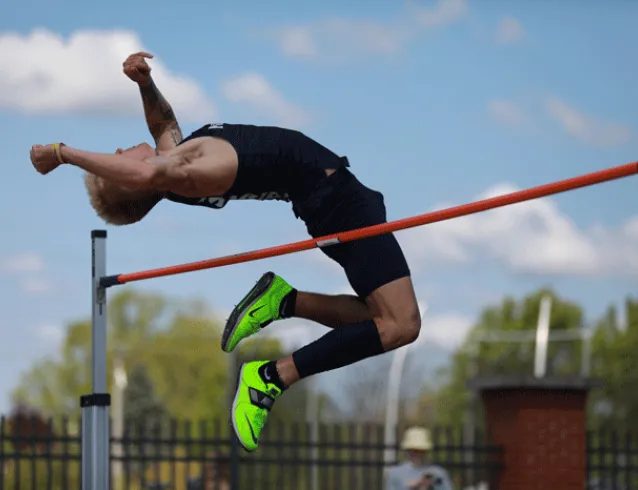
[232,260,421,451]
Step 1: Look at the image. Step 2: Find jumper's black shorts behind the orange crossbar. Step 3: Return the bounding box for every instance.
[293,167,410,299]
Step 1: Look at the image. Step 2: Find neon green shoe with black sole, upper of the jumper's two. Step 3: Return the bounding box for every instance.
[222,272,293,352]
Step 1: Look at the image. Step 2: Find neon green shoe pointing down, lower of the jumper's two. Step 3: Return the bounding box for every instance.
[232,361,281,452]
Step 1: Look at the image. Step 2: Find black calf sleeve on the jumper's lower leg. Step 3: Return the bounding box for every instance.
[292,320,385,379]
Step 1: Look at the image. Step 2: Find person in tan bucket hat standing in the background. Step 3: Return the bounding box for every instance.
[383,427,454,490]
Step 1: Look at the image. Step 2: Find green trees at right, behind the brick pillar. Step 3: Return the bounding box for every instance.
[421,289,638,430]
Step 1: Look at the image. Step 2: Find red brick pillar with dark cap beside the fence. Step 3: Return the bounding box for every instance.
[470,378,592,490]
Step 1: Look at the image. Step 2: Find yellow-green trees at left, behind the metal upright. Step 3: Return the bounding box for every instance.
[13,289,316,420]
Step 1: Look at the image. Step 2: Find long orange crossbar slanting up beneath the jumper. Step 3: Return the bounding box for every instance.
[100,162,638,287]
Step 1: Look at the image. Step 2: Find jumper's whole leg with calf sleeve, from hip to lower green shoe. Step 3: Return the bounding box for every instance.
[232,167,421,450]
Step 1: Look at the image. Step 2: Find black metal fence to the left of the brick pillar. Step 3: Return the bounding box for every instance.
[0,418,500,490]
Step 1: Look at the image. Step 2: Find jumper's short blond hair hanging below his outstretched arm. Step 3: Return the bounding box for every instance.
[84,173,163,226]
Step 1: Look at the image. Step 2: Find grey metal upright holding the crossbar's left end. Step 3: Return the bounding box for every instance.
[80,230,111,490]
